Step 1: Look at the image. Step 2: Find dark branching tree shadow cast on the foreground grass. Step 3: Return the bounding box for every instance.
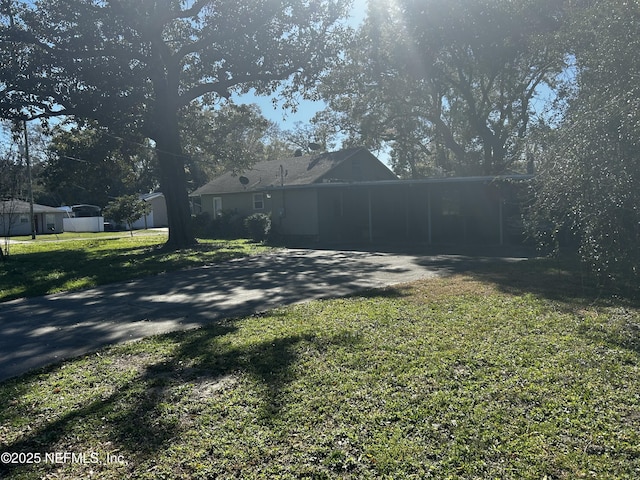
[0,320,360,478]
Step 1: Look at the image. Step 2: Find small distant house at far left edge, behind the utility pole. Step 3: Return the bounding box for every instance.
[0,200,65,236]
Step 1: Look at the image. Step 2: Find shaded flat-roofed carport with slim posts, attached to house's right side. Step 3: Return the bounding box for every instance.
[314,175,531,245]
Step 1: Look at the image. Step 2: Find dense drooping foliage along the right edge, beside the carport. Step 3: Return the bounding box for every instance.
[530,1,640,279]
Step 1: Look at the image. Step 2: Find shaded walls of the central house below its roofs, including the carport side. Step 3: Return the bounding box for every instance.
[202,179,523,245]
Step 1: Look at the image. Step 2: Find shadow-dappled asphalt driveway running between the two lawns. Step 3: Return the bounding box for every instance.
[0,249,528,381]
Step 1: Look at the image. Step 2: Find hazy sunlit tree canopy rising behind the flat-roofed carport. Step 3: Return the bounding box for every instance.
[323,0,564,176]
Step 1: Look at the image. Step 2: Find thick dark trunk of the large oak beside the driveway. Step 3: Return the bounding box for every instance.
[155,109,196,250]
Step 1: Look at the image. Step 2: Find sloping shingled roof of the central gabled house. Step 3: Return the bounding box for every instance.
[191,147,393,196]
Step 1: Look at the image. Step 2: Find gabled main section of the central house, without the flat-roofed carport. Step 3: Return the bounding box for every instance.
[191,148,398,237]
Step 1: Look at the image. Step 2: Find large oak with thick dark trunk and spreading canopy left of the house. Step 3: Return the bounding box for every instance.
[0,0,348,248]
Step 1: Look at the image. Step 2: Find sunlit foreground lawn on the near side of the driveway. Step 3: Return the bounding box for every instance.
[0,262,640,480]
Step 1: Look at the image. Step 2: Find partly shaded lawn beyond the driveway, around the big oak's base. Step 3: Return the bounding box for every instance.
[0,231,267,302]
